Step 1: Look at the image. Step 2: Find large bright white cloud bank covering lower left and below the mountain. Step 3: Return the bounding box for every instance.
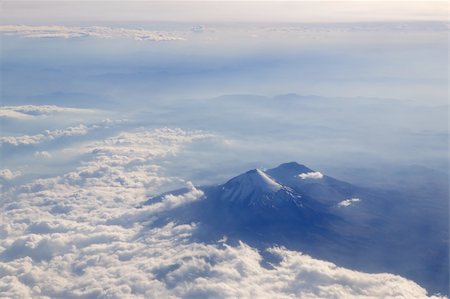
[0,129,442,298]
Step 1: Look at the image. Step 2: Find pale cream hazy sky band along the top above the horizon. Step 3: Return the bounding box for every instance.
[1,1,448,24]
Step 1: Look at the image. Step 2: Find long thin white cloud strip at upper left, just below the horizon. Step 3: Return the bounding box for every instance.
[0,25,183,41]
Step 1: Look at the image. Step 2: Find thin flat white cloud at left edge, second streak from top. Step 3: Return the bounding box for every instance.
[0,105,94,119]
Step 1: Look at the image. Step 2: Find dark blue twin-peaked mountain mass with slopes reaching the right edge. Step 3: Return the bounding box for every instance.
[147,162,449,294]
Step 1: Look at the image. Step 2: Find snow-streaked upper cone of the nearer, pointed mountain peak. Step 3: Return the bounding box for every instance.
[220,169,301,206]
